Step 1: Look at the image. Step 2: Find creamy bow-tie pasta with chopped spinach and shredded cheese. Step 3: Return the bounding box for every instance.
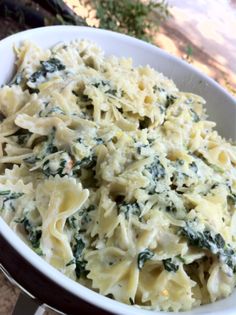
[0,40,236,311]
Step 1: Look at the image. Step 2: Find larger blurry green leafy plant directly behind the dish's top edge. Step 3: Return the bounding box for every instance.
[92,0,170,41]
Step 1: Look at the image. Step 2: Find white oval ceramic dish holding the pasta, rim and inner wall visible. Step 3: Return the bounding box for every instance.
[0,26,236,315]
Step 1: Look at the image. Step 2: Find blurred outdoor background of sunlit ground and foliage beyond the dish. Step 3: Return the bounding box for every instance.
[0,0,236,315]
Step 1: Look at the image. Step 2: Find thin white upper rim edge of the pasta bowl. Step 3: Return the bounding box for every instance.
[0,25,236,315]
